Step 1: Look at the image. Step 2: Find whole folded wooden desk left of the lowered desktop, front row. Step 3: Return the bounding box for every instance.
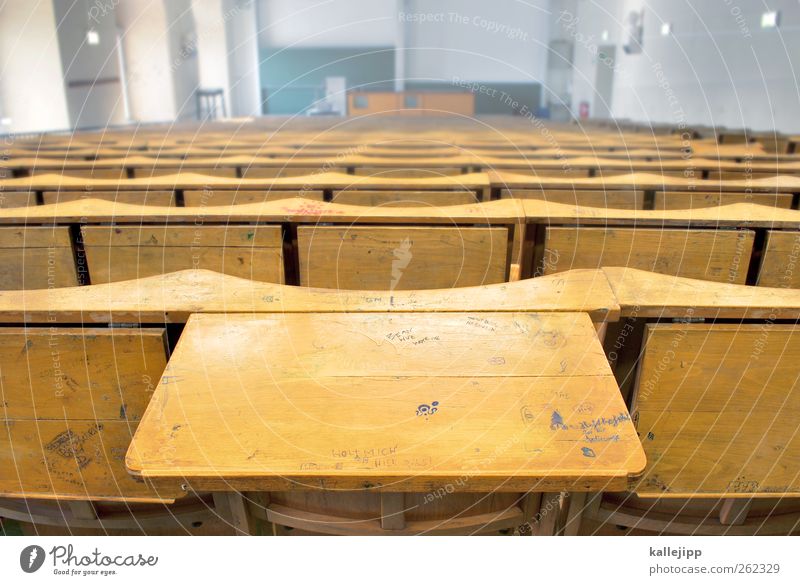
[0,327,179,502]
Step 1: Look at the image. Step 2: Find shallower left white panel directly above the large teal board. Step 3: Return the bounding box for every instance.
[258,0,396,47]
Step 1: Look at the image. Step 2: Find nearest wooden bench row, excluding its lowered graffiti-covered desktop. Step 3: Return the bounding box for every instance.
[0,268,800,534]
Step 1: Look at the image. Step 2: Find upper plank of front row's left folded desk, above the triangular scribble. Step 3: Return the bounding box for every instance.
[0,327,167,421]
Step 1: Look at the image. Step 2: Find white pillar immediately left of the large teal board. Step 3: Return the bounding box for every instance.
[222,0,261,116]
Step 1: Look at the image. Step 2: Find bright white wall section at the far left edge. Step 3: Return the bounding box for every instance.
[0,0,69,132]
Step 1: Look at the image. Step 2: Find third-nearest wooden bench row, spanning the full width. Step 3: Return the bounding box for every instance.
[0,171,800,209]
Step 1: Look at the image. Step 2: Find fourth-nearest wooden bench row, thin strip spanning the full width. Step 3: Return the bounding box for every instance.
[0,152,800,180]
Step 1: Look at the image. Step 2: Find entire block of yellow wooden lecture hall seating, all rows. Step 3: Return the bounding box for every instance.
[0,117,800,535]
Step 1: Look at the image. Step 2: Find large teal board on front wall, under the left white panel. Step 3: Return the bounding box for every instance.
[260,47,394,115]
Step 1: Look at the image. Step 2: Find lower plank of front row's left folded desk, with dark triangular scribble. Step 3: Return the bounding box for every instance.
[0,419,181,501]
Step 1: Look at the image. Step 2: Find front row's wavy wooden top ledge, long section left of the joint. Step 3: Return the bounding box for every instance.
[0,269,619,323]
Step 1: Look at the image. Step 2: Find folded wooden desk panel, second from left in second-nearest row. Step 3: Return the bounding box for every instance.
[82,226,284,283]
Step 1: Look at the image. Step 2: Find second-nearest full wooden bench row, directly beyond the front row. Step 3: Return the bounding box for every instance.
[0,198,800,290]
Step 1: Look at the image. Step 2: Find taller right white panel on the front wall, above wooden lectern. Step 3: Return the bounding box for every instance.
[406,0,550,83]
